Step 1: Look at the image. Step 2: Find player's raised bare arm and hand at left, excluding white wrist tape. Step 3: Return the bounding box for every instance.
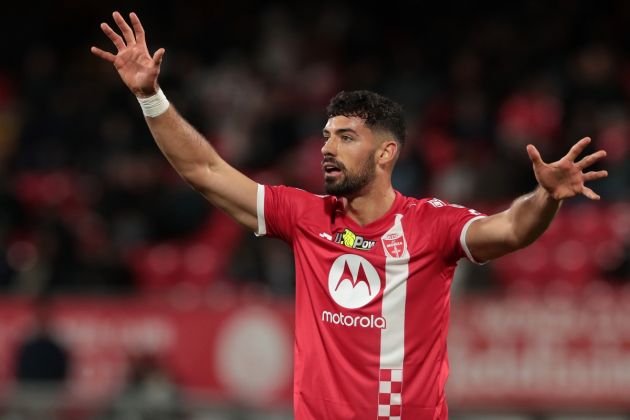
[91,12,258,231]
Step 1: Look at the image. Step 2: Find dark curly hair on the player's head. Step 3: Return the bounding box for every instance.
[326,90,406,146]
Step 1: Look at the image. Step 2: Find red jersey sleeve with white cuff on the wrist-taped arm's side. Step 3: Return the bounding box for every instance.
[256,184,303,242]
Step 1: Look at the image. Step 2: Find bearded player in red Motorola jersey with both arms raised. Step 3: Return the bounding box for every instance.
[92,12,607,420]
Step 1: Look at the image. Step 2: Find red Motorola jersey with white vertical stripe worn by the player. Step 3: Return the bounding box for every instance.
[257,185,483,420]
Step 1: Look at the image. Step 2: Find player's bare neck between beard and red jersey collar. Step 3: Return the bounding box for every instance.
[346,184,396,226]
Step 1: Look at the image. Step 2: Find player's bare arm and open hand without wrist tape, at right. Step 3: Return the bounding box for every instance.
[465,137,608,261]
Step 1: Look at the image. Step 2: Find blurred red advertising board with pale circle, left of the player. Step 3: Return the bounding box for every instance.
[0,296,293,406]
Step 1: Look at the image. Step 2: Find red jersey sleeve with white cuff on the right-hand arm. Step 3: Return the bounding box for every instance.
[425,198,487,264]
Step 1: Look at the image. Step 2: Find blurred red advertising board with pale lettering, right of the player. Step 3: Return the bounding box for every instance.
[447,287,630,410]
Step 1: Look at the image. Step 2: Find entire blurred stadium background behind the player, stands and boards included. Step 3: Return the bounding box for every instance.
[0,0,630,420]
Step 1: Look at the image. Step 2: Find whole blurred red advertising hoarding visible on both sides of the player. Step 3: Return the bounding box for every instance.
[0,288,630,409]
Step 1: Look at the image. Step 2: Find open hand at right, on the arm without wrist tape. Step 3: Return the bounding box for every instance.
[527,137,608,200]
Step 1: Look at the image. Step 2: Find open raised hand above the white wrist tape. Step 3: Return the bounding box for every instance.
[91,12,165,97]
